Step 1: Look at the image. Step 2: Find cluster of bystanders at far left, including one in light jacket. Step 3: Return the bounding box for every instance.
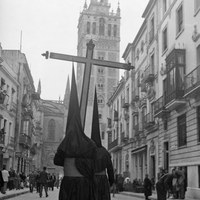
[0,166,26,194]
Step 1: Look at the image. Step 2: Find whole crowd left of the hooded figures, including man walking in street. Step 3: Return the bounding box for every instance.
[0,167,60,197]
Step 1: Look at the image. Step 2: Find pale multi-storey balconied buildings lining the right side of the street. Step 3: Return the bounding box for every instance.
[110,0,200,199]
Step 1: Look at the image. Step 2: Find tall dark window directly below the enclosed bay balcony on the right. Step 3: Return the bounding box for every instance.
[177,114,187,147]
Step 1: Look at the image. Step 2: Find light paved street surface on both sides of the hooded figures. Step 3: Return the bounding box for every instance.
[12,188,141,200]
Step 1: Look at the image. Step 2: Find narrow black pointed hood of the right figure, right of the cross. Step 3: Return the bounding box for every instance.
[91,88,102,147]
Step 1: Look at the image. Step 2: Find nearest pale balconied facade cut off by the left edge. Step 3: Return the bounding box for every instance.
[0,44,19,169]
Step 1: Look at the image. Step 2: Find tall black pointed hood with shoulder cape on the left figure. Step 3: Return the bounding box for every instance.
[58,65,96,158]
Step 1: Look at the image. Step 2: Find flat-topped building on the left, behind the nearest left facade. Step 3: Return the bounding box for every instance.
[2,50,39,173]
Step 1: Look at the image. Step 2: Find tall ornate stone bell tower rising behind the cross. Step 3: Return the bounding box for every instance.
[77,0,120,146]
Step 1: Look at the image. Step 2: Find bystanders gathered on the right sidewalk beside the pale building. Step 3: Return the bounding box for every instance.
[144,167,186,200]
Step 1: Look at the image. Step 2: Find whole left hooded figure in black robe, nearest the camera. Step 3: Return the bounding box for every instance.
[54,68,96,200]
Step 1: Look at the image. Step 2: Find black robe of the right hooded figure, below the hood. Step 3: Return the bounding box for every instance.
[95,147,114,200]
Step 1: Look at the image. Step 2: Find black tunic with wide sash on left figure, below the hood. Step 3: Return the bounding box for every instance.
[54,151,97,200]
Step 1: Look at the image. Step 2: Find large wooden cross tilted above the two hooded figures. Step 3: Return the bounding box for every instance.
[42,40,134,130]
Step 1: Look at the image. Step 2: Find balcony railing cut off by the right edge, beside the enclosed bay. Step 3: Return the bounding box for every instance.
[185,65,200,96]
